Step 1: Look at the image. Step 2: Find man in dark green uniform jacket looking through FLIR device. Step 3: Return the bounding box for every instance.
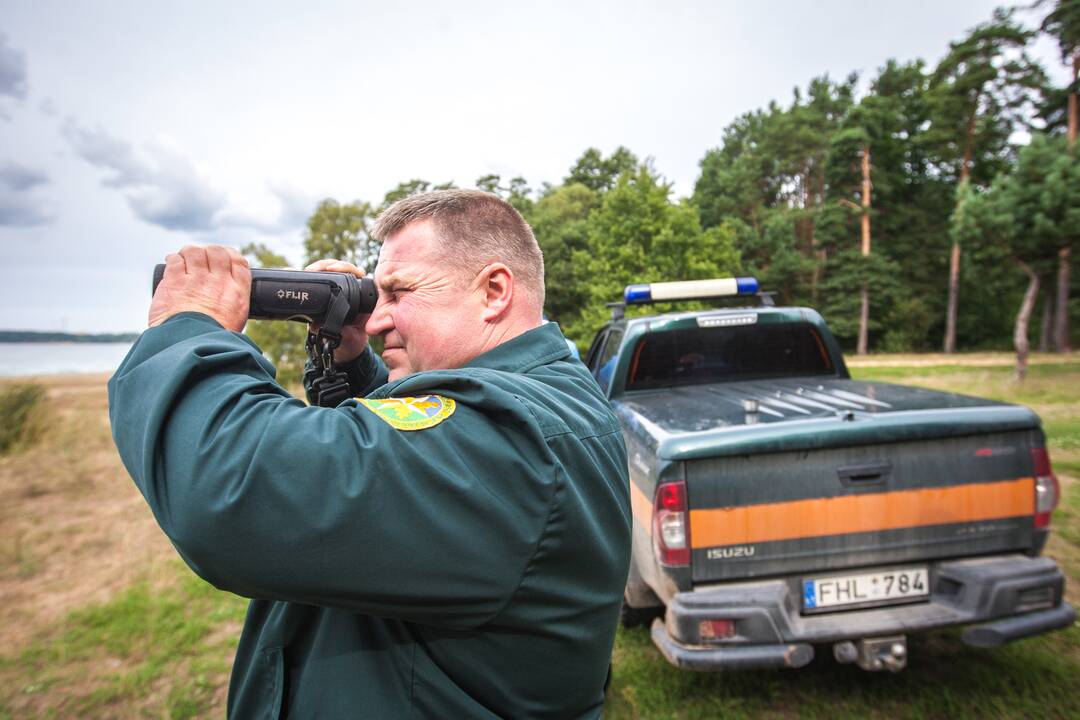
[109,191,631,718]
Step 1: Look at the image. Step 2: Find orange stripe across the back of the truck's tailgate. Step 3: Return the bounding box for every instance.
[686,477,1035,547]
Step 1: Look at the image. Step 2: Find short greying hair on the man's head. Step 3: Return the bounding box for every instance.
[372,190,544,308]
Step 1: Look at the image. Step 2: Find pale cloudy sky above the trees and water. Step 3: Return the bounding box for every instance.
[0,0,1067,332]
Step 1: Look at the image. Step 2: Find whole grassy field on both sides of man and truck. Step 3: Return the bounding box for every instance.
[0,354,1080,719]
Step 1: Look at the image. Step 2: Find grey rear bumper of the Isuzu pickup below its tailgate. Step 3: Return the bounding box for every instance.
[652,555,1076,670]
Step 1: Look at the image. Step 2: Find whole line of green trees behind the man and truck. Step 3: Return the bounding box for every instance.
[245,0,1080,386]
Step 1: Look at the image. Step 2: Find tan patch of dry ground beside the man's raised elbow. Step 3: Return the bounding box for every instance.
[0,375,176,651]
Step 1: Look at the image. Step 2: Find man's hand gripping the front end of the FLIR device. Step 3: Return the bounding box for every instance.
[149,245,252,332]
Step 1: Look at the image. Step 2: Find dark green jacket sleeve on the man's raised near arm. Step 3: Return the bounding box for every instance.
[109,314,561,627]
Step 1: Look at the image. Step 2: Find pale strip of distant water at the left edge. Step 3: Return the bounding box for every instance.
[0,342,132,378]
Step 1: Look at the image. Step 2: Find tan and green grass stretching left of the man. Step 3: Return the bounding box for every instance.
[0,376,240,718]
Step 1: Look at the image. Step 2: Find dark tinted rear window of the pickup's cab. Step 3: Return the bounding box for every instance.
[626,323,836,390]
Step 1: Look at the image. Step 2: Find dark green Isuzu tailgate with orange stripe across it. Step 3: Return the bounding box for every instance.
[685,427,1036,583]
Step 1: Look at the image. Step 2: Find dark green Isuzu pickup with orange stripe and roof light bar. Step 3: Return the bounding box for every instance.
[585,279,1076,671]
